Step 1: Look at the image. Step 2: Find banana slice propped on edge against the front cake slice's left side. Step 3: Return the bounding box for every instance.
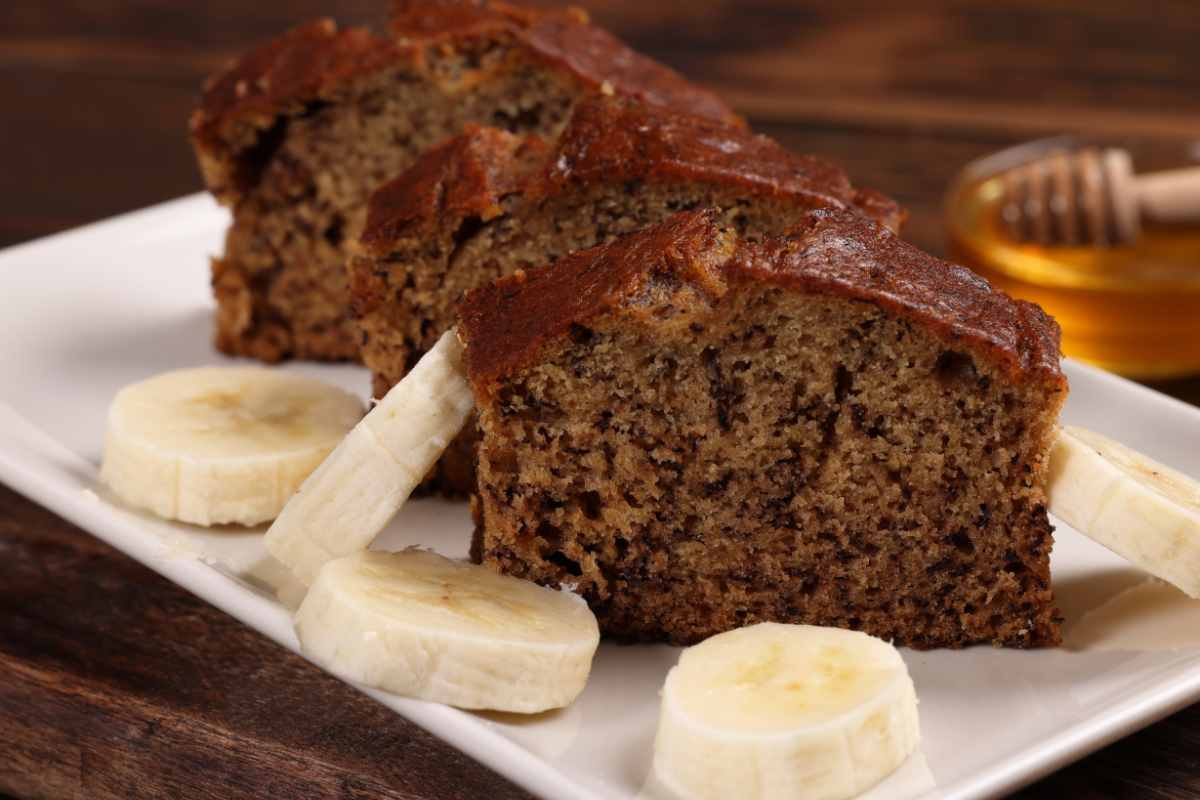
[266,330,475,584]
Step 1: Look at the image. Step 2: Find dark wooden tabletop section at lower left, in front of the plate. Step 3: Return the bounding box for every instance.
[0,487,528,800]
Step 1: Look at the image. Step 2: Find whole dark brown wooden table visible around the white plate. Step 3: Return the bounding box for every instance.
[0,0,1200,800]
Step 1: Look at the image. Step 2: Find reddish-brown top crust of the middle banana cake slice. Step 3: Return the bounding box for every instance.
[361,97,904,250]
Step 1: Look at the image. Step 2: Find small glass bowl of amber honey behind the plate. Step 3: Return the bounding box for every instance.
[946,138,1200,380]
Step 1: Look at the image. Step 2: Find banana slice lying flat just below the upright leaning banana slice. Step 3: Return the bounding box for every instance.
[295,549,600,714]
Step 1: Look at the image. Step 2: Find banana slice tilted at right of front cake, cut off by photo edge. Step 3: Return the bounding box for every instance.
[1050,427,1200,599]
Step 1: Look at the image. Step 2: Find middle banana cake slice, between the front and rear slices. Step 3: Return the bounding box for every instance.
[349,97,901,493]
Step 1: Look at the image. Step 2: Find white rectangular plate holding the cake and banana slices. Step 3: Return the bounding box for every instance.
[0,196,1200,800]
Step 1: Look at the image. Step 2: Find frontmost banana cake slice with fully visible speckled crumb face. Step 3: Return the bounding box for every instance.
[461,209,1067,648]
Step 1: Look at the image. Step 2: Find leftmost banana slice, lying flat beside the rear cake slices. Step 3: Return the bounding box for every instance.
[100,367,362,525]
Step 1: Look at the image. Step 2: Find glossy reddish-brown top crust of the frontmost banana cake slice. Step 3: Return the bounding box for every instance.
[460,209,1066,395]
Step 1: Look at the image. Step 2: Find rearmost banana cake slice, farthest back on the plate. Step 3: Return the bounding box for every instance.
[192,0,742,361]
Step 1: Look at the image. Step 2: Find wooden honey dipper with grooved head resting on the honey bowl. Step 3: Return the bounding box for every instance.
[1001,148,1200,247]
